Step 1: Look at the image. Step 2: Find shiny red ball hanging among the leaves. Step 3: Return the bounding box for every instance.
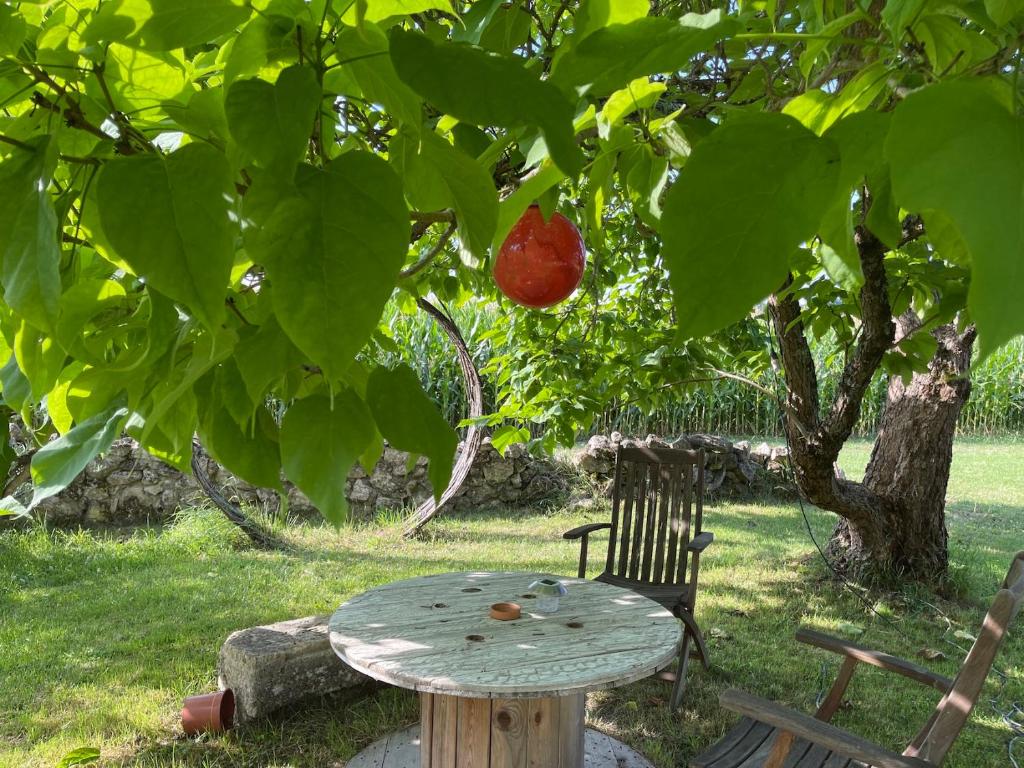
[495,205,587,309]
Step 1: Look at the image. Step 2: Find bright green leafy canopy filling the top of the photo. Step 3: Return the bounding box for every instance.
[0,0,1024,520]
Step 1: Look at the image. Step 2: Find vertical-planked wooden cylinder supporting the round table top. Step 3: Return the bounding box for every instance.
[420,693,586,768]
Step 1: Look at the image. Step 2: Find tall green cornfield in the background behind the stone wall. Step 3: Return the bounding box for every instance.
[386,304,1024,436]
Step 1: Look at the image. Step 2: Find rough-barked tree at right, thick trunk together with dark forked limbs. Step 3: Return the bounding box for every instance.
[768,217,975,584]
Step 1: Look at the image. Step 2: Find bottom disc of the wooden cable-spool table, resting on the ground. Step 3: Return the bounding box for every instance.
[346,725,653,768]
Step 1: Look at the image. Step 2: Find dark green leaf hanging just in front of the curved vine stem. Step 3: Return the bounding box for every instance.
[367,365,459,499]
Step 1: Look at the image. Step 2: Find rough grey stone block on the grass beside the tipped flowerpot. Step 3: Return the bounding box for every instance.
[218,615,369,723]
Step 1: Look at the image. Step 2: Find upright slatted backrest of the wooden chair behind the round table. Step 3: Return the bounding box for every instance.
[604,446,705,584]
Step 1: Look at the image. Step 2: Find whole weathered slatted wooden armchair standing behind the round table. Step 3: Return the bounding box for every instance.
[563,446,715,709]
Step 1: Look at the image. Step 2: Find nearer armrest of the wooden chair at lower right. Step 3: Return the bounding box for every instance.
[718,688,935,768]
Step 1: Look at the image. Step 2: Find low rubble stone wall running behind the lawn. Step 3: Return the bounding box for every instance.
[0,432,792,525]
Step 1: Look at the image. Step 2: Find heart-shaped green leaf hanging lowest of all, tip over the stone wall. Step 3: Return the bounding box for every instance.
[281,387,376,525]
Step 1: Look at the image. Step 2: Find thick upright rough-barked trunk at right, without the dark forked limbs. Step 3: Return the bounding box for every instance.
[828,315,975,584]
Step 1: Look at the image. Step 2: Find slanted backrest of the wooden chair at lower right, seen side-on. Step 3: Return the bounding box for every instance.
[904,552,1024,765]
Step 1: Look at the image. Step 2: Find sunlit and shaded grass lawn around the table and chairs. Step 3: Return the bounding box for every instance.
[0,441,1024,768]
